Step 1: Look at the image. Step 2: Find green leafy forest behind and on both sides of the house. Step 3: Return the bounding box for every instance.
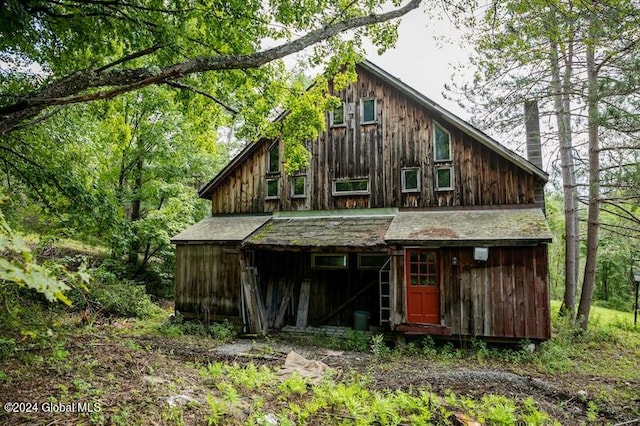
[0,0,640,342]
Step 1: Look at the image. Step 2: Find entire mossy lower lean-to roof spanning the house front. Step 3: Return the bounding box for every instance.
[171,208,552,250]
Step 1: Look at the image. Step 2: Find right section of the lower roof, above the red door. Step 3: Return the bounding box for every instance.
[384,208,552,247]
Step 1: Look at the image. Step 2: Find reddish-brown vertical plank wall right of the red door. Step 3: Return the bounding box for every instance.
[440,246,551,339]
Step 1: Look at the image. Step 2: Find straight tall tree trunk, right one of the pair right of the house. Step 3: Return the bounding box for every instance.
[577,20,600,330]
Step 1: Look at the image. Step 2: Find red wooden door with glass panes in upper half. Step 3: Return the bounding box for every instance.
[405,249,440,324]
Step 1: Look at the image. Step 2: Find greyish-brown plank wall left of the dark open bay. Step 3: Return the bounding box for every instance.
[175,244,240,319]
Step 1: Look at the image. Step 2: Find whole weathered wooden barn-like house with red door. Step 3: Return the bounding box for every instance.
[173,62,551,340]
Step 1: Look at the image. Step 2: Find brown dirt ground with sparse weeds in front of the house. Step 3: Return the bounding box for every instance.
[0,332,640,425]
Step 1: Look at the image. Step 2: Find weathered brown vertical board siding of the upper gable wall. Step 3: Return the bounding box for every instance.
[212,65,535,214]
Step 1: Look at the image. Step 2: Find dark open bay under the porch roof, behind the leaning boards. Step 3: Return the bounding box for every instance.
[255,250,379,327]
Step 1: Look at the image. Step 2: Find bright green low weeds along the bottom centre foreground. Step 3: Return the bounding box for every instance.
[195,362,557,425]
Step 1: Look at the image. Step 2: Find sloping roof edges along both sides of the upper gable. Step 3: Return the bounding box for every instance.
[198,60,549,199]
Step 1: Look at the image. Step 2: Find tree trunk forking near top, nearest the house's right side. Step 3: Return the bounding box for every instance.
[549,40,580,320]
